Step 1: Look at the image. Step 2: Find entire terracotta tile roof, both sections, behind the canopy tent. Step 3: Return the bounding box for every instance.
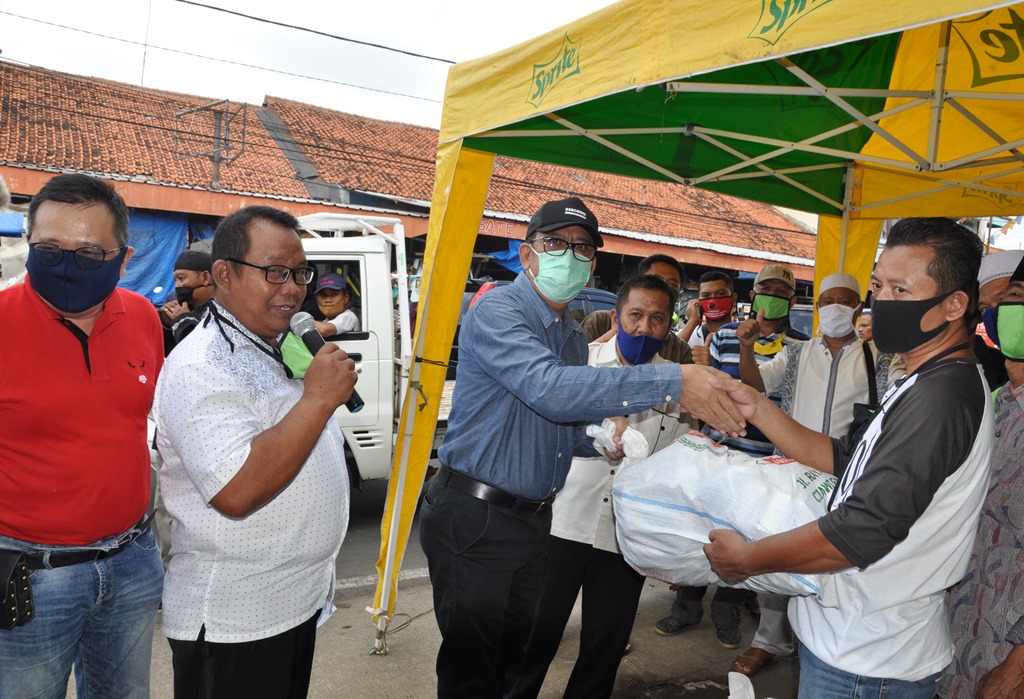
[0,62,815,259]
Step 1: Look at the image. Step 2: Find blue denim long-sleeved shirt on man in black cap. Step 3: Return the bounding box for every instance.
[438,274,682,500]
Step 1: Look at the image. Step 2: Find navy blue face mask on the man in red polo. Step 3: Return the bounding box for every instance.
[25,246,128,313]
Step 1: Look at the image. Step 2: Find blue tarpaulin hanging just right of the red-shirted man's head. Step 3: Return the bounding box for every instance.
[120,209,188,303]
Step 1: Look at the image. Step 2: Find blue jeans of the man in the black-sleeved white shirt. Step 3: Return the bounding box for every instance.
[799,644,942,699]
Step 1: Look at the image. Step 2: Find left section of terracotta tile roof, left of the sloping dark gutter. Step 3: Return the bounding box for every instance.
[0,62,308,196]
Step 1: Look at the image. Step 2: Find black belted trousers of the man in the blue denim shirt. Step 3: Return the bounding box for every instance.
[420,479,551,699]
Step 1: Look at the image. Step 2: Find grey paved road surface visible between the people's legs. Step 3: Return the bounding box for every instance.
[69,482,798,699]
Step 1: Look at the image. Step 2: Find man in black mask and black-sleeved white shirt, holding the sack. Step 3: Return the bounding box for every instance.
[705,218,994,699]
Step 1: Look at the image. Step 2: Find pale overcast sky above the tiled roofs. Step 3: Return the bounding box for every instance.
[0,0,611,128]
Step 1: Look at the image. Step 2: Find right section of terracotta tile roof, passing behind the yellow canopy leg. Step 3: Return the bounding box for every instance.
[265,97,816,259]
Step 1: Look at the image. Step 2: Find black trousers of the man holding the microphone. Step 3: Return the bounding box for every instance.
[168,612,319,699]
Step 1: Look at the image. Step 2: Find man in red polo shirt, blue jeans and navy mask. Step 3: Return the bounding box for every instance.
[0,170,163,699]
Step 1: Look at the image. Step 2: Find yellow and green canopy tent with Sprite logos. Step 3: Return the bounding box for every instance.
[374,0,1024,646]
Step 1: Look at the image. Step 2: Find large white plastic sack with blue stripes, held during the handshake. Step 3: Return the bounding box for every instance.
[611,432,836,598]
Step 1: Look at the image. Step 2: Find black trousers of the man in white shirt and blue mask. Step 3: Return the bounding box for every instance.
[505,536,644,699]
